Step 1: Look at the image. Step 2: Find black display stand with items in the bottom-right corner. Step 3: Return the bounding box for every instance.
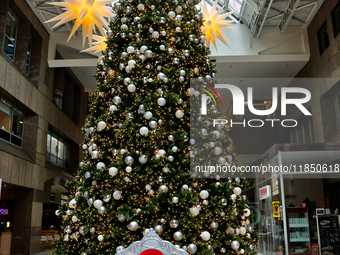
[317,215,340,255]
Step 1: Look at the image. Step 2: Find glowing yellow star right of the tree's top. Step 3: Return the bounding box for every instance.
[200,0,234,51]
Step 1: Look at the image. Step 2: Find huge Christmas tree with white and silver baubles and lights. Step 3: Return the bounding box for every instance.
[54,0,256,255]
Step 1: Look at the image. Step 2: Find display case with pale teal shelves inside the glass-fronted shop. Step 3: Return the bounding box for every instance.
[286,208,310,254]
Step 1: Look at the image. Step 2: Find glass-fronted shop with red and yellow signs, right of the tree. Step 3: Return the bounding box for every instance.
[247,144,340,255]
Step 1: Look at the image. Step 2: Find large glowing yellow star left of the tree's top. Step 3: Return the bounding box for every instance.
[46,0,113,47]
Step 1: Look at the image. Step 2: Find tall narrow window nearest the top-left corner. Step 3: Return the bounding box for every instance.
[4,10,18,60]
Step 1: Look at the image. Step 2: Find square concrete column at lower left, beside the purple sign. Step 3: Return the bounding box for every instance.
[11,188,43,255]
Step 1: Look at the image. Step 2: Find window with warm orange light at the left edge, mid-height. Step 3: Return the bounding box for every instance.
[0,97,24,147]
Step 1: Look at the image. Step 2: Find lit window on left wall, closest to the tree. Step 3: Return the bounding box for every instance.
[46,128,71,169]
